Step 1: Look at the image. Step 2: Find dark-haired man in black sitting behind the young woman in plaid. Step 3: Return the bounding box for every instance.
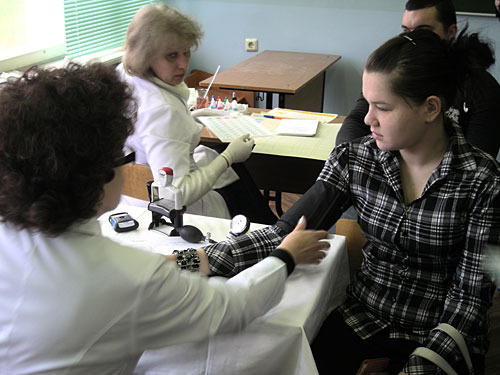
[336,0,500,158]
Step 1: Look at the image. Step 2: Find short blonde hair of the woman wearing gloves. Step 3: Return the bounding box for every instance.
[123,3,203,78]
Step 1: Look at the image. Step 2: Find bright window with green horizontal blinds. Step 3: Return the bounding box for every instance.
[0,0,151,72]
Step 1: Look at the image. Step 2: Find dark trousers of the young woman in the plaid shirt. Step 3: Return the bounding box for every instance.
[311,311,484,375]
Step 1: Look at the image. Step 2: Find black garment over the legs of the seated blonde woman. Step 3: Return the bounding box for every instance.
[215,163,278,224]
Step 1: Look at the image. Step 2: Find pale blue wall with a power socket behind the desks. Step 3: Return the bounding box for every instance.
[168,0,500,114]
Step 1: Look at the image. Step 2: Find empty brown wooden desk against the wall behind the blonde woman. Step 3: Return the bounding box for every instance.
[200,51,340,112]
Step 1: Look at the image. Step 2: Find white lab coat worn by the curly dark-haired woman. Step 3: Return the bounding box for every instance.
[0,219,287,375]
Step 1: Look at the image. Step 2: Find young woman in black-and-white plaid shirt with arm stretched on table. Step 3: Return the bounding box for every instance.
[200,29,500,374]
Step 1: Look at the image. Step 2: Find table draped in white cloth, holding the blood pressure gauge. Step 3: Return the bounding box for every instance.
[97,206,349,375]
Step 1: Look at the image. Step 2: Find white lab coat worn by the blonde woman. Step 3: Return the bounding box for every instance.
[117,65,238,218]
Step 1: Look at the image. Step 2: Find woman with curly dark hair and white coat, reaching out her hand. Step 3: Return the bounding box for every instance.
[0,64,327,374]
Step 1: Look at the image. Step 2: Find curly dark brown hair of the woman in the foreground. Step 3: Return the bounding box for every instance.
[0,65,135,235]
